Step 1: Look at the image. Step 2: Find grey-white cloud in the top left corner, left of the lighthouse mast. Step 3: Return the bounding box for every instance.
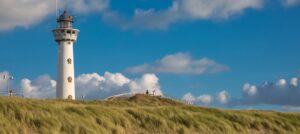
[0,0,55,30]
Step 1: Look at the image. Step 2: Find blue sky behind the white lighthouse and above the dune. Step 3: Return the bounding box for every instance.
[0,0,300,110]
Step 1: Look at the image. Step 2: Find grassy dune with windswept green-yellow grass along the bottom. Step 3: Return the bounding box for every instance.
[0,95,300,134]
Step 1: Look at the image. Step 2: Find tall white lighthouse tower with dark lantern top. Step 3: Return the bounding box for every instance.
[53,10,79,100]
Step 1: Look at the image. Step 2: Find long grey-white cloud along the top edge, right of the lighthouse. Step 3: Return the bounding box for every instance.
[104,0,263,29]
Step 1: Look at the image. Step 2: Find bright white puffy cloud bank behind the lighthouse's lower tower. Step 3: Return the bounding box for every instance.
[20,72,163,99]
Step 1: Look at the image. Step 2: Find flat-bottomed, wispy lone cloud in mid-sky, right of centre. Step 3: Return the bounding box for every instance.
[127,53,228,75]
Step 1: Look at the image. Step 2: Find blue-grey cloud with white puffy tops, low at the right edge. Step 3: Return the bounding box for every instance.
[235,78,300,107]
